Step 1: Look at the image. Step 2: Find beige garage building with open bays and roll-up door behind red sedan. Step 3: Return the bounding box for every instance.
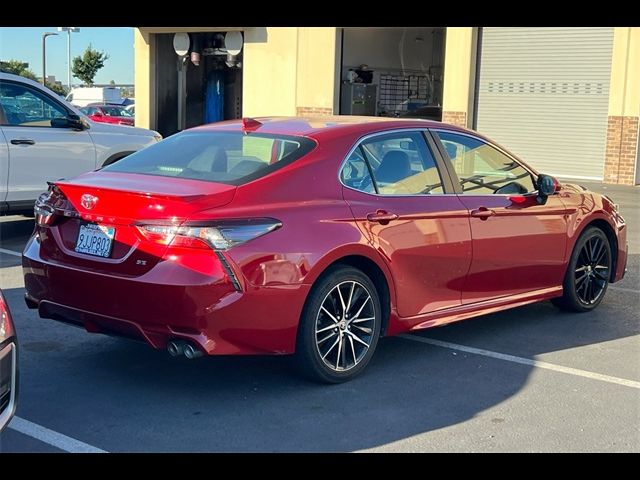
[135,27,640,185]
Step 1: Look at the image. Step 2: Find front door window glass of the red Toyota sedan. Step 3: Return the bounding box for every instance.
[437,131,535,195]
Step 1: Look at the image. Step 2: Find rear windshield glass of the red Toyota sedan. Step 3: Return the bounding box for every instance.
[103,131,315,185]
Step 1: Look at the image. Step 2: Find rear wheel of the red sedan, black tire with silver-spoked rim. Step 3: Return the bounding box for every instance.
[293,265,382,383]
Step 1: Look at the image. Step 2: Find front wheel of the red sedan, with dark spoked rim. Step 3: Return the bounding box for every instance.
[552,227,613,312]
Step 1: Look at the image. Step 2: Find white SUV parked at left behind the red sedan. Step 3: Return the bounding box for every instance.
[0,73,162,213]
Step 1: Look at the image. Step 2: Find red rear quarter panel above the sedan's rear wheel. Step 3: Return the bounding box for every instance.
[182,136,395,308]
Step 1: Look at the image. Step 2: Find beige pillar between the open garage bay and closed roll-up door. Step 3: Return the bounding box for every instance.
[442,27,477,124]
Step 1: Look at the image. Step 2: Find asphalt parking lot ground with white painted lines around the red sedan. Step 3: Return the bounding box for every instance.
[0,185,640,452]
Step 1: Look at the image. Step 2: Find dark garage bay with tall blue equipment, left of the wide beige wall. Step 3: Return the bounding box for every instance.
[155,32,242,137]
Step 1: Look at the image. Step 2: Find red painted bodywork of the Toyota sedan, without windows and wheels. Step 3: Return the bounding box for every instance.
[23,117,627,354]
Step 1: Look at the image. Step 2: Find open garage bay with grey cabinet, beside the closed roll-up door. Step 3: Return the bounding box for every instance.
[340,27,446,120]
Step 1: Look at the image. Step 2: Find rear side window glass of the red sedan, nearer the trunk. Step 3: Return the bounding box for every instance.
[341,132,444,195]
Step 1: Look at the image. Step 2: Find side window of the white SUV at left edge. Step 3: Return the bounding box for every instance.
[0,82,67,127]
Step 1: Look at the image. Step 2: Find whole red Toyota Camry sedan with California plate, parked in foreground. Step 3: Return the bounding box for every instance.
[23,116,627,382]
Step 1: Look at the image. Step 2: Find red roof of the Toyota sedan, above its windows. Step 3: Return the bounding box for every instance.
[190,115,475,139]
